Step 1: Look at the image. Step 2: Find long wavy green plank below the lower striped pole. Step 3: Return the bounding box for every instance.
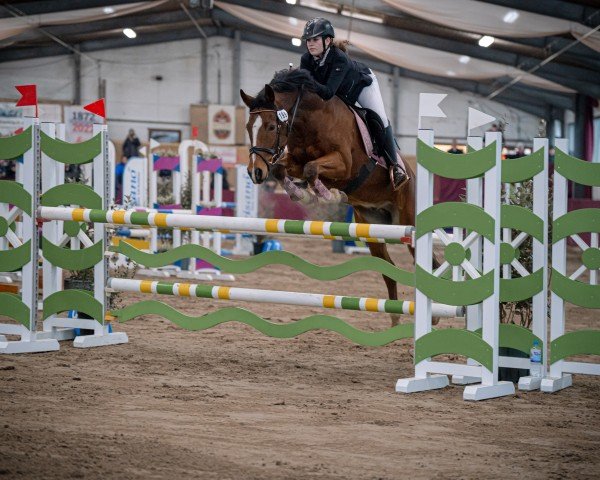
[111,300,414,347]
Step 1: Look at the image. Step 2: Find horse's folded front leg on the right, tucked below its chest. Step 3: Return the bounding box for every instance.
[304,152,350,203]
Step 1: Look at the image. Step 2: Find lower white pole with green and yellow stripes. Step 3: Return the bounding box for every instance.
[107,278,464,317]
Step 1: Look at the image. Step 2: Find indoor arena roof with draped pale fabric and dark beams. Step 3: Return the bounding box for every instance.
[0,0,600,114]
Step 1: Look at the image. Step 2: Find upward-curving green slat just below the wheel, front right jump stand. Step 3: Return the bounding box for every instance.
[416,265,494,306]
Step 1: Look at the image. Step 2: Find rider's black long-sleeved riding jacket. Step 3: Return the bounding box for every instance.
[300,45,373,105]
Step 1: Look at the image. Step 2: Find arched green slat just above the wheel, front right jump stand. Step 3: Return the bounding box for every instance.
[416,202,494,242]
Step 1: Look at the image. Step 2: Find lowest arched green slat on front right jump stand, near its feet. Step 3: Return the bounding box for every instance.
[415,328,493,370]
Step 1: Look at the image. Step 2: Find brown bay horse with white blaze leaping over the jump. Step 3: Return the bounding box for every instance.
[240,69,422,326]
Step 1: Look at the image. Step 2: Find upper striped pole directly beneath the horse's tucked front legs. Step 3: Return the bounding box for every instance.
[38,207,414,243]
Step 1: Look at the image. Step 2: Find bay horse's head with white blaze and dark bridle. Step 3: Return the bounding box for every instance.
[240,85,288,183]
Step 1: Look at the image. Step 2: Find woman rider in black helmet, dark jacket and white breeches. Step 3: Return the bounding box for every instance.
[300,18,407,189]
